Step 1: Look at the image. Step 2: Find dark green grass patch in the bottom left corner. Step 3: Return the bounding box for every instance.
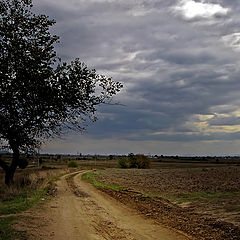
[0,217,27,240]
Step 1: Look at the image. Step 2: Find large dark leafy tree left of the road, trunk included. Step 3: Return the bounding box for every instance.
[0,0,122,184]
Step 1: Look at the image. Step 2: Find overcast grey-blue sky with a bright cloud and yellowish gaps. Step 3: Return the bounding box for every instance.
[34,0,240,155]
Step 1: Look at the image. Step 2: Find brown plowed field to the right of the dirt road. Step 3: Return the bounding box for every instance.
[93,166,240,240]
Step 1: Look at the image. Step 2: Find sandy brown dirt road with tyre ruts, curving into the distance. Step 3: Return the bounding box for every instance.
[34,172,191,240]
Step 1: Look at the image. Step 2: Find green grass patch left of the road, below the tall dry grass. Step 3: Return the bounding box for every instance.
[0,189,47,215]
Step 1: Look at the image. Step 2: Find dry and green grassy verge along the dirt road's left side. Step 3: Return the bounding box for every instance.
[0,169,68,240]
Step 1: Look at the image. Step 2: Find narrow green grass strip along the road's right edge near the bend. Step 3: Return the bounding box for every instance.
[82,172,124,191]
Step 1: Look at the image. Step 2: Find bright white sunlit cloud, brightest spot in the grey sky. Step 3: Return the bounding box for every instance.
[174,0,229,20]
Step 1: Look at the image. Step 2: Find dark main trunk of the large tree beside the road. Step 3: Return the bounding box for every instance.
[5,147,20,186]
